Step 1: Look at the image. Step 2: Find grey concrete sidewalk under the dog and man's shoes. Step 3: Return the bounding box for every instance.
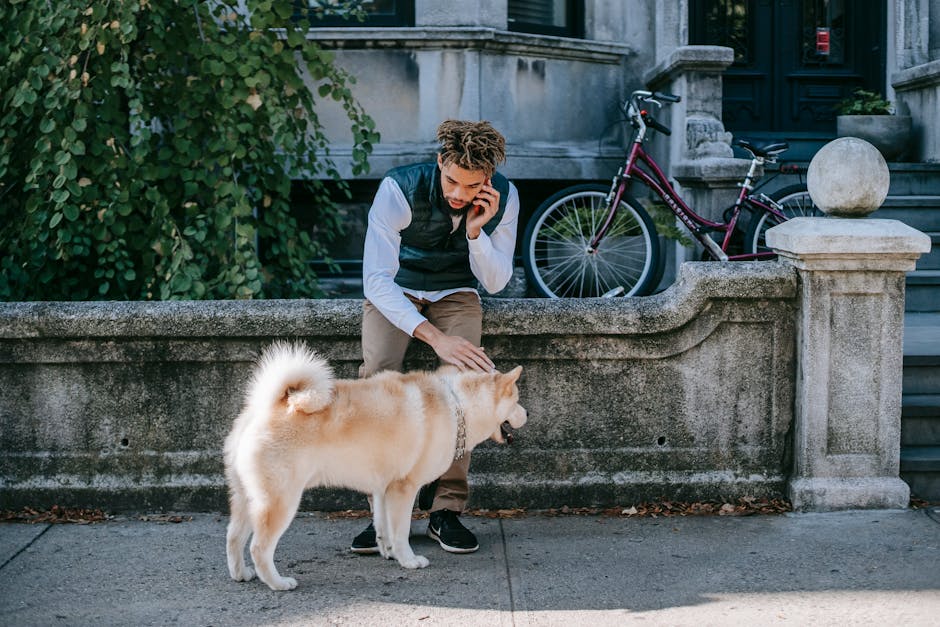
[0,508,940,626]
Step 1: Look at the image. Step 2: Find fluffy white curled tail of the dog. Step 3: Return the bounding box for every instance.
[248,342,333,414]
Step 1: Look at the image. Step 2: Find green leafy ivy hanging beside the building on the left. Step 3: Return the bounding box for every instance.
[0,0,379,300]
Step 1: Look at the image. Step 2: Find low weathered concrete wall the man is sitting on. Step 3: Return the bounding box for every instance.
[0,263,797,510]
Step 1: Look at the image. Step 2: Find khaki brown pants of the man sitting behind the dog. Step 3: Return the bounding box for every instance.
[359,292,483,513]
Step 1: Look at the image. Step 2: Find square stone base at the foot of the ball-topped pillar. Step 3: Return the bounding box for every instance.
[789,477,911,512]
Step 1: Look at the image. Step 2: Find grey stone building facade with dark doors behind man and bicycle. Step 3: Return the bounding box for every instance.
[299,0,940,292]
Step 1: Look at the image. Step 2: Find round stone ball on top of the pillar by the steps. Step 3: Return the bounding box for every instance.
[806,137,891,218]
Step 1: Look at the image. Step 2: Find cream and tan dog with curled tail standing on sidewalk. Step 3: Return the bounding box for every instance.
[225,342,526,590]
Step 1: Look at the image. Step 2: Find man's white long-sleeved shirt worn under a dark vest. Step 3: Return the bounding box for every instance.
[362,178,519,336]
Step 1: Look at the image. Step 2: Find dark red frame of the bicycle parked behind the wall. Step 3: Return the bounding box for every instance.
[588,111,786,261]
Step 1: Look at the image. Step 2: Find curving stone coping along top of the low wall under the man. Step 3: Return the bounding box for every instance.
[0,262,796,339]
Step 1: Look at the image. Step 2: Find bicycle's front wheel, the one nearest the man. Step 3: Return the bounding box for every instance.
[522,185,659,298]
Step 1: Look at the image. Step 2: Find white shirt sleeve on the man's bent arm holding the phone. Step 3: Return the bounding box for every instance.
[467,183,519,294]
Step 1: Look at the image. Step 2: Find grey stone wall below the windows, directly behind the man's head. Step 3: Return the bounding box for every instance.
[309,0,653,180]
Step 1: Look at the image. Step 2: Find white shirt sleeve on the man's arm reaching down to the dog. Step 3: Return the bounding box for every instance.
[362,178,426,336]
